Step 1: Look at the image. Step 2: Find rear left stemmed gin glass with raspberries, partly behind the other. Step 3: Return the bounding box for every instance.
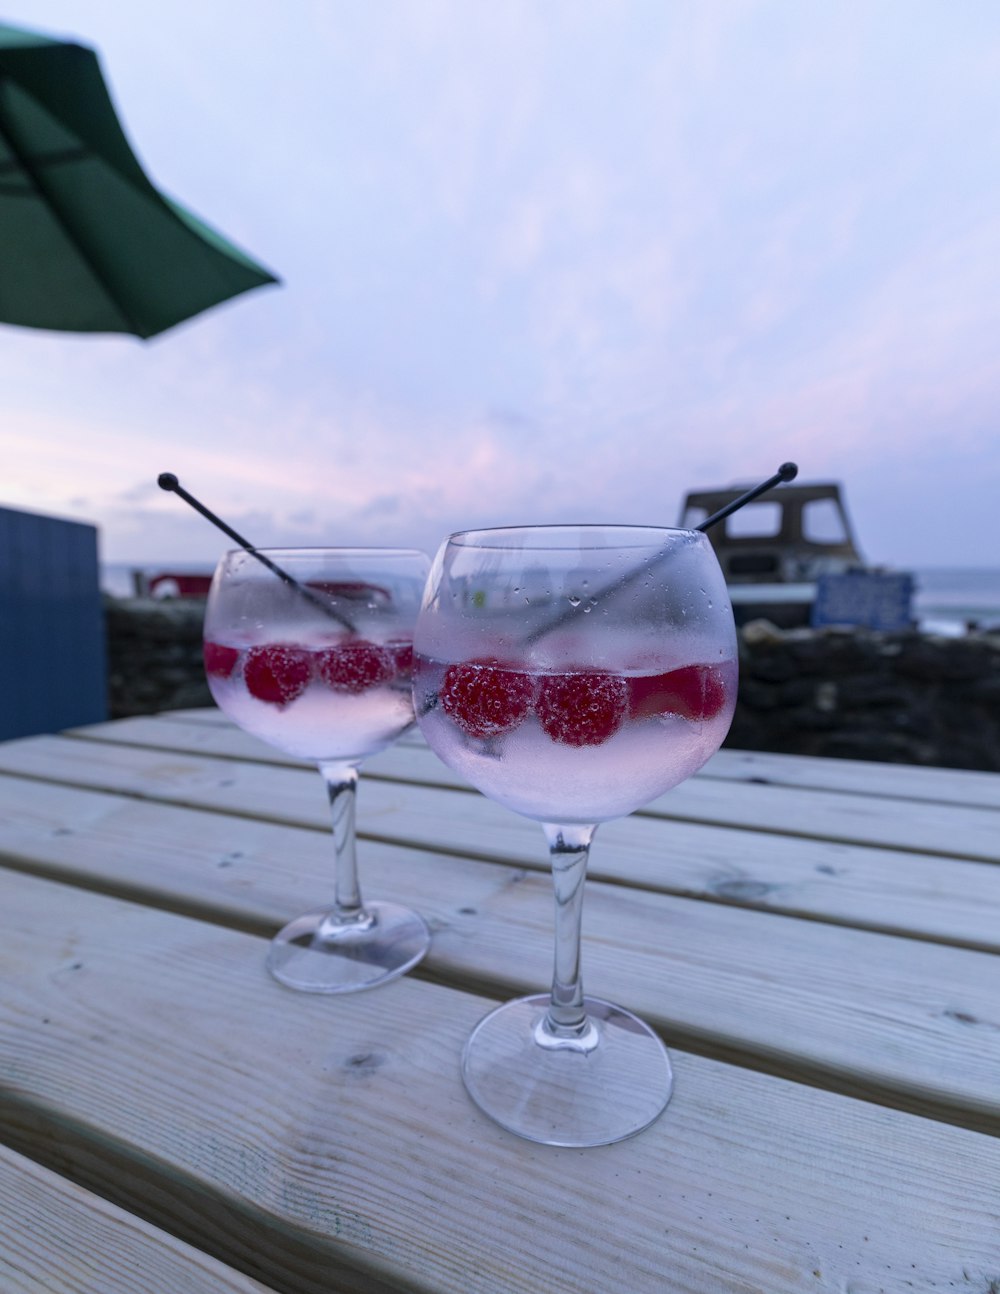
[204,549,429,992]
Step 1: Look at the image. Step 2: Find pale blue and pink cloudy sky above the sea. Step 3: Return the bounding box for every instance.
[0,0,1000,565]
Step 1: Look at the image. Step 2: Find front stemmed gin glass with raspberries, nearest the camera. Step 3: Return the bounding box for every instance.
[414,525,736,1146]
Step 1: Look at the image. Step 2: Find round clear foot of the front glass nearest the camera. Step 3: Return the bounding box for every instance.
[462,994,674,1146]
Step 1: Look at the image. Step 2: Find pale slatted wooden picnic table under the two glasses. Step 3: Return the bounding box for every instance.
[0,710,1000,1294]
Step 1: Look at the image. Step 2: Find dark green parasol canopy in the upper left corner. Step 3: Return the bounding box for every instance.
[0,25,278,338]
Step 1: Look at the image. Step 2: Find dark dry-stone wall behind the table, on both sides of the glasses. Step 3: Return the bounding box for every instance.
[106,598,1000,771]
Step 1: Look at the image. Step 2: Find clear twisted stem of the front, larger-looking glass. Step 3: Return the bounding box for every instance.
[542,823,596,1040]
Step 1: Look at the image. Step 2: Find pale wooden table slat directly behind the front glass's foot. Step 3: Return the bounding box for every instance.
[0,779,1000,1127]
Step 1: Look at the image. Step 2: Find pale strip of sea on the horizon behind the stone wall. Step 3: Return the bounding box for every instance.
[101,562,1000,637]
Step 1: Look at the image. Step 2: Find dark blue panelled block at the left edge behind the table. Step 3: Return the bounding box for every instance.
[0,507,107,740]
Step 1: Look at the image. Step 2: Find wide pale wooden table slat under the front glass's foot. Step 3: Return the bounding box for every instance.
[0,876,1000,1294]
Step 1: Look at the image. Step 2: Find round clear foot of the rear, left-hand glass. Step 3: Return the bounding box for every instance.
[268,901,431,992]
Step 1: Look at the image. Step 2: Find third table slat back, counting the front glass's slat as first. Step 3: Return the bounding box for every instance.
[0,739,1000,949]
